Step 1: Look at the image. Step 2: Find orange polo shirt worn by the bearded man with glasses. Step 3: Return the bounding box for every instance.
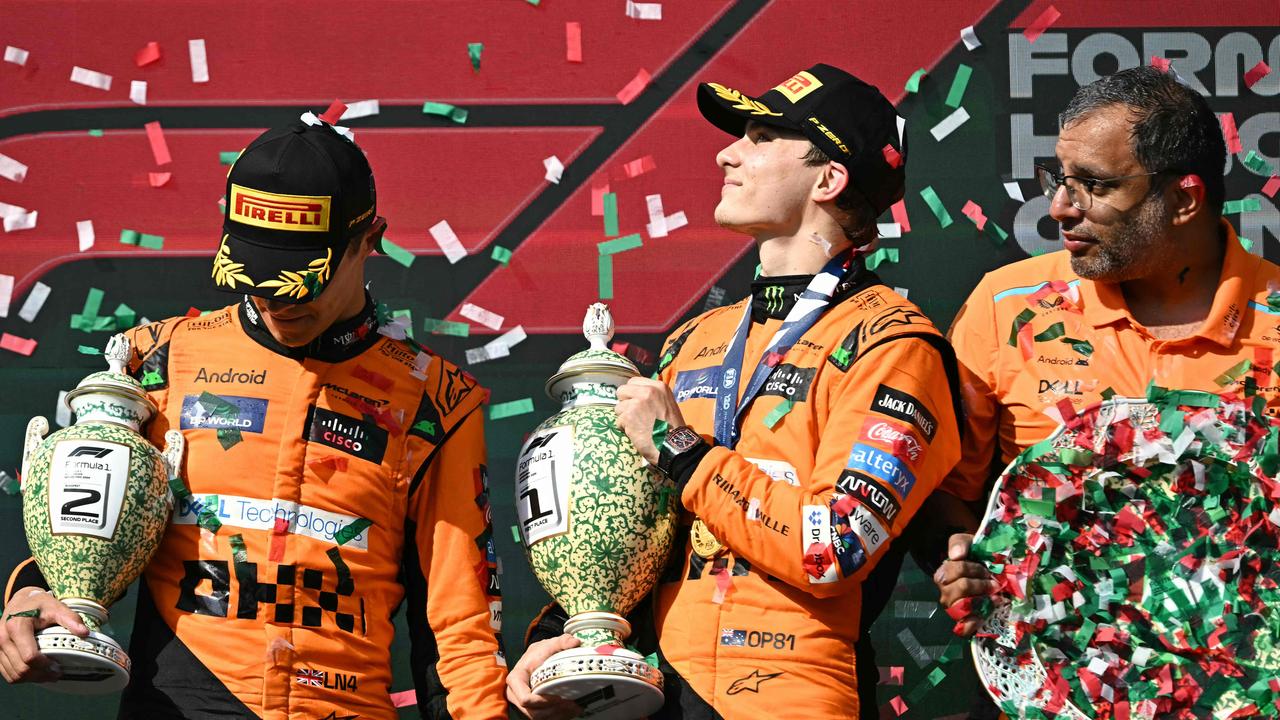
[941,220,1280,501]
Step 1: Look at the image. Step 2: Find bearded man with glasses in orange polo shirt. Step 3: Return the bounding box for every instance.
[925,68,1280,707]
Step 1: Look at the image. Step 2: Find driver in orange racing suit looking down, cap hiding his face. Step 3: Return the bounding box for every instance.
[0,114,507,720]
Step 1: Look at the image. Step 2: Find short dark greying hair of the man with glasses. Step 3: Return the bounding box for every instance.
[1059,67,1226,215]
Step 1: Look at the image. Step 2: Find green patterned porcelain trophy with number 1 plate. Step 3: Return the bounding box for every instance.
[516,302,678,720]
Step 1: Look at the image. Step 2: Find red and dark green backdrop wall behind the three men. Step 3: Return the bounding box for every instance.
[0,0,1280,720]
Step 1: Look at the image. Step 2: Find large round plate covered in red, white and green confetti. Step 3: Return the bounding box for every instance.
[965,387,1280,720]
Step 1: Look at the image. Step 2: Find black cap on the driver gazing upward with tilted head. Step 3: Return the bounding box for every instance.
[698,64,906,215]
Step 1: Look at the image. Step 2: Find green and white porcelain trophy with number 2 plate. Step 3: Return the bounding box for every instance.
[22,334,186,694]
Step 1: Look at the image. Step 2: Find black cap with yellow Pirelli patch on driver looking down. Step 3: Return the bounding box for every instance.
[212,120,378,304]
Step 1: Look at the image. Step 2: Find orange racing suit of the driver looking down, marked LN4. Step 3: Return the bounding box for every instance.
[9,299,507,720]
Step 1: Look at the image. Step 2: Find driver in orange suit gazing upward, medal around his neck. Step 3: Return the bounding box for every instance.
[508,65,960,720]
